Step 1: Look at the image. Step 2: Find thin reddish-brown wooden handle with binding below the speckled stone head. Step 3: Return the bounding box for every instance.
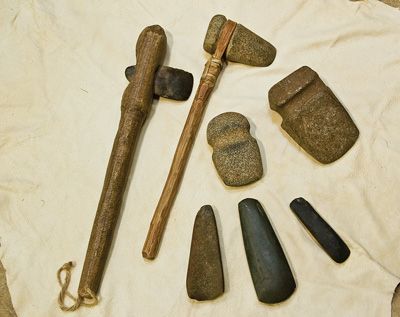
[142,20,236,259]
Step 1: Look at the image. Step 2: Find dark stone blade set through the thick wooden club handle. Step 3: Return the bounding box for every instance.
[125,66,193,100]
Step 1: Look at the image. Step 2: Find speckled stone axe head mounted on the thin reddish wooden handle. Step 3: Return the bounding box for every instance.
[203,14,276,66]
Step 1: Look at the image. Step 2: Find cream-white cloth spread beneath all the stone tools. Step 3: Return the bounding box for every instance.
[0,0,400,317]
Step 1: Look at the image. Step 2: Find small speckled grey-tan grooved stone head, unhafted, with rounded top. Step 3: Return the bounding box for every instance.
[207,112,263,186]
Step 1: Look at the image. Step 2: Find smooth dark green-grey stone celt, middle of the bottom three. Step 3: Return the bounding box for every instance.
[239,198,296,304]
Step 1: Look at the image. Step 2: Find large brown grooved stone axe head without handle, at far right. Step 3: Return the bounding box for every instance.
[268,66,359,164]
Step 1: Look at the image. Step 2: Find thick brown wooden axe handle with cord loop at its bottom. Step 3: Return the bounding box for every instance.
[57,25,194,311]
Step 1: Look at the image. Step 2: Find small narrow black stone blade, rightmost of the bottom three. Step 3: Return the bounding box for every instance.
[290,197,350,263]
